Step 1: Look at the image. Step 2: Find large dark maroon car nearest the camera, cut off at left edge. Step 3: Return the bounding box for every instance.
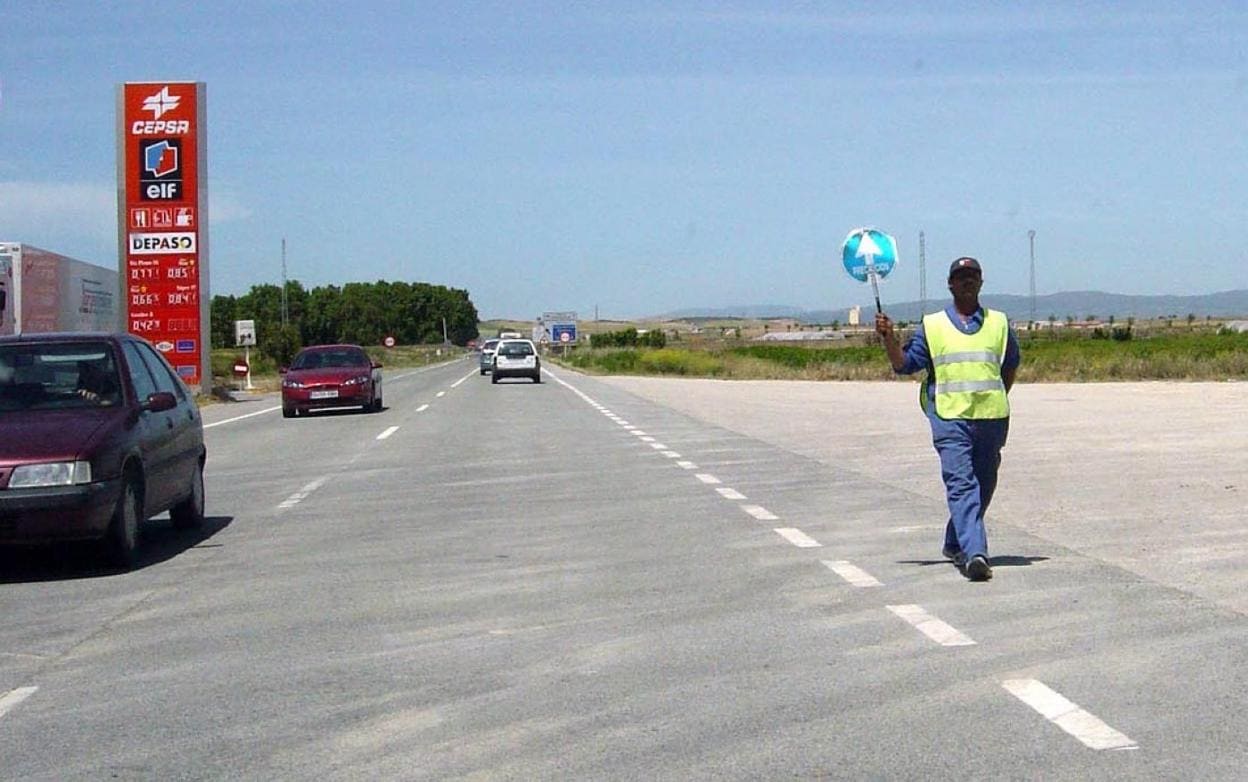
[0,333,207,567]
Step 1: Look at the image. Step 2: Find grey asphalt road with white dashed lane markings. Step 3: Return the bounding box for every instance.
[0,362,1248,780]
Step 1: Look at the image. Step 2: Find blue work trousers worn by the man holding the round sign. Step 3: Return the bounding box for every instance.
[927,414,1010,559]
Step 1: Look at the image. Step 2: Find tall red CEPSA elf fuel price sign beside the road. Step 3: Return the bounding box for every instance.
[117,81,211,390]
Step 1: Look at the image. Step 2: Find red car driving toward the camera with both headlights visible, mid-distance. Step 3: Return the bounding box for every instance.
[281,344,382,418]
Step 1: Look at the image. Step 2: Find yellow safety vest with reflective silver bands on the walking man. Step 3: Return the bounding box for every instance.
[920,308,1010,419]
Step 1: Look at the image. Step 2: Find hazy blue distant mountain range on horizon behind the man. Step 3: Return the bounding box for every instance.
[654,291,1248,323]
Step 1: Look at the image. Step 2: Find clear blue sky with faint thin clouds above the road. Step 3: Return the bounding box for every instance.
[0,0,1248,319]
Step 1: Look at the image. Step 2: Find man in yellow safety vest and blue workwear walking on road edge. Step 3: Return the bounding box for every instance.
[875,258,1020,581]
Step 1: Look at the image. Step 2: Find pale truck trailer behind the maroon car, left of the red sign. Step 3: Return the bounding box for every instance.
[0,242,121,335]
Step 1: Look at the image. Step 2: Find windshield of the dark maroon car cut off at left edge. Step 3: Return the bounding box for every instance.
[0,342,121,413]
